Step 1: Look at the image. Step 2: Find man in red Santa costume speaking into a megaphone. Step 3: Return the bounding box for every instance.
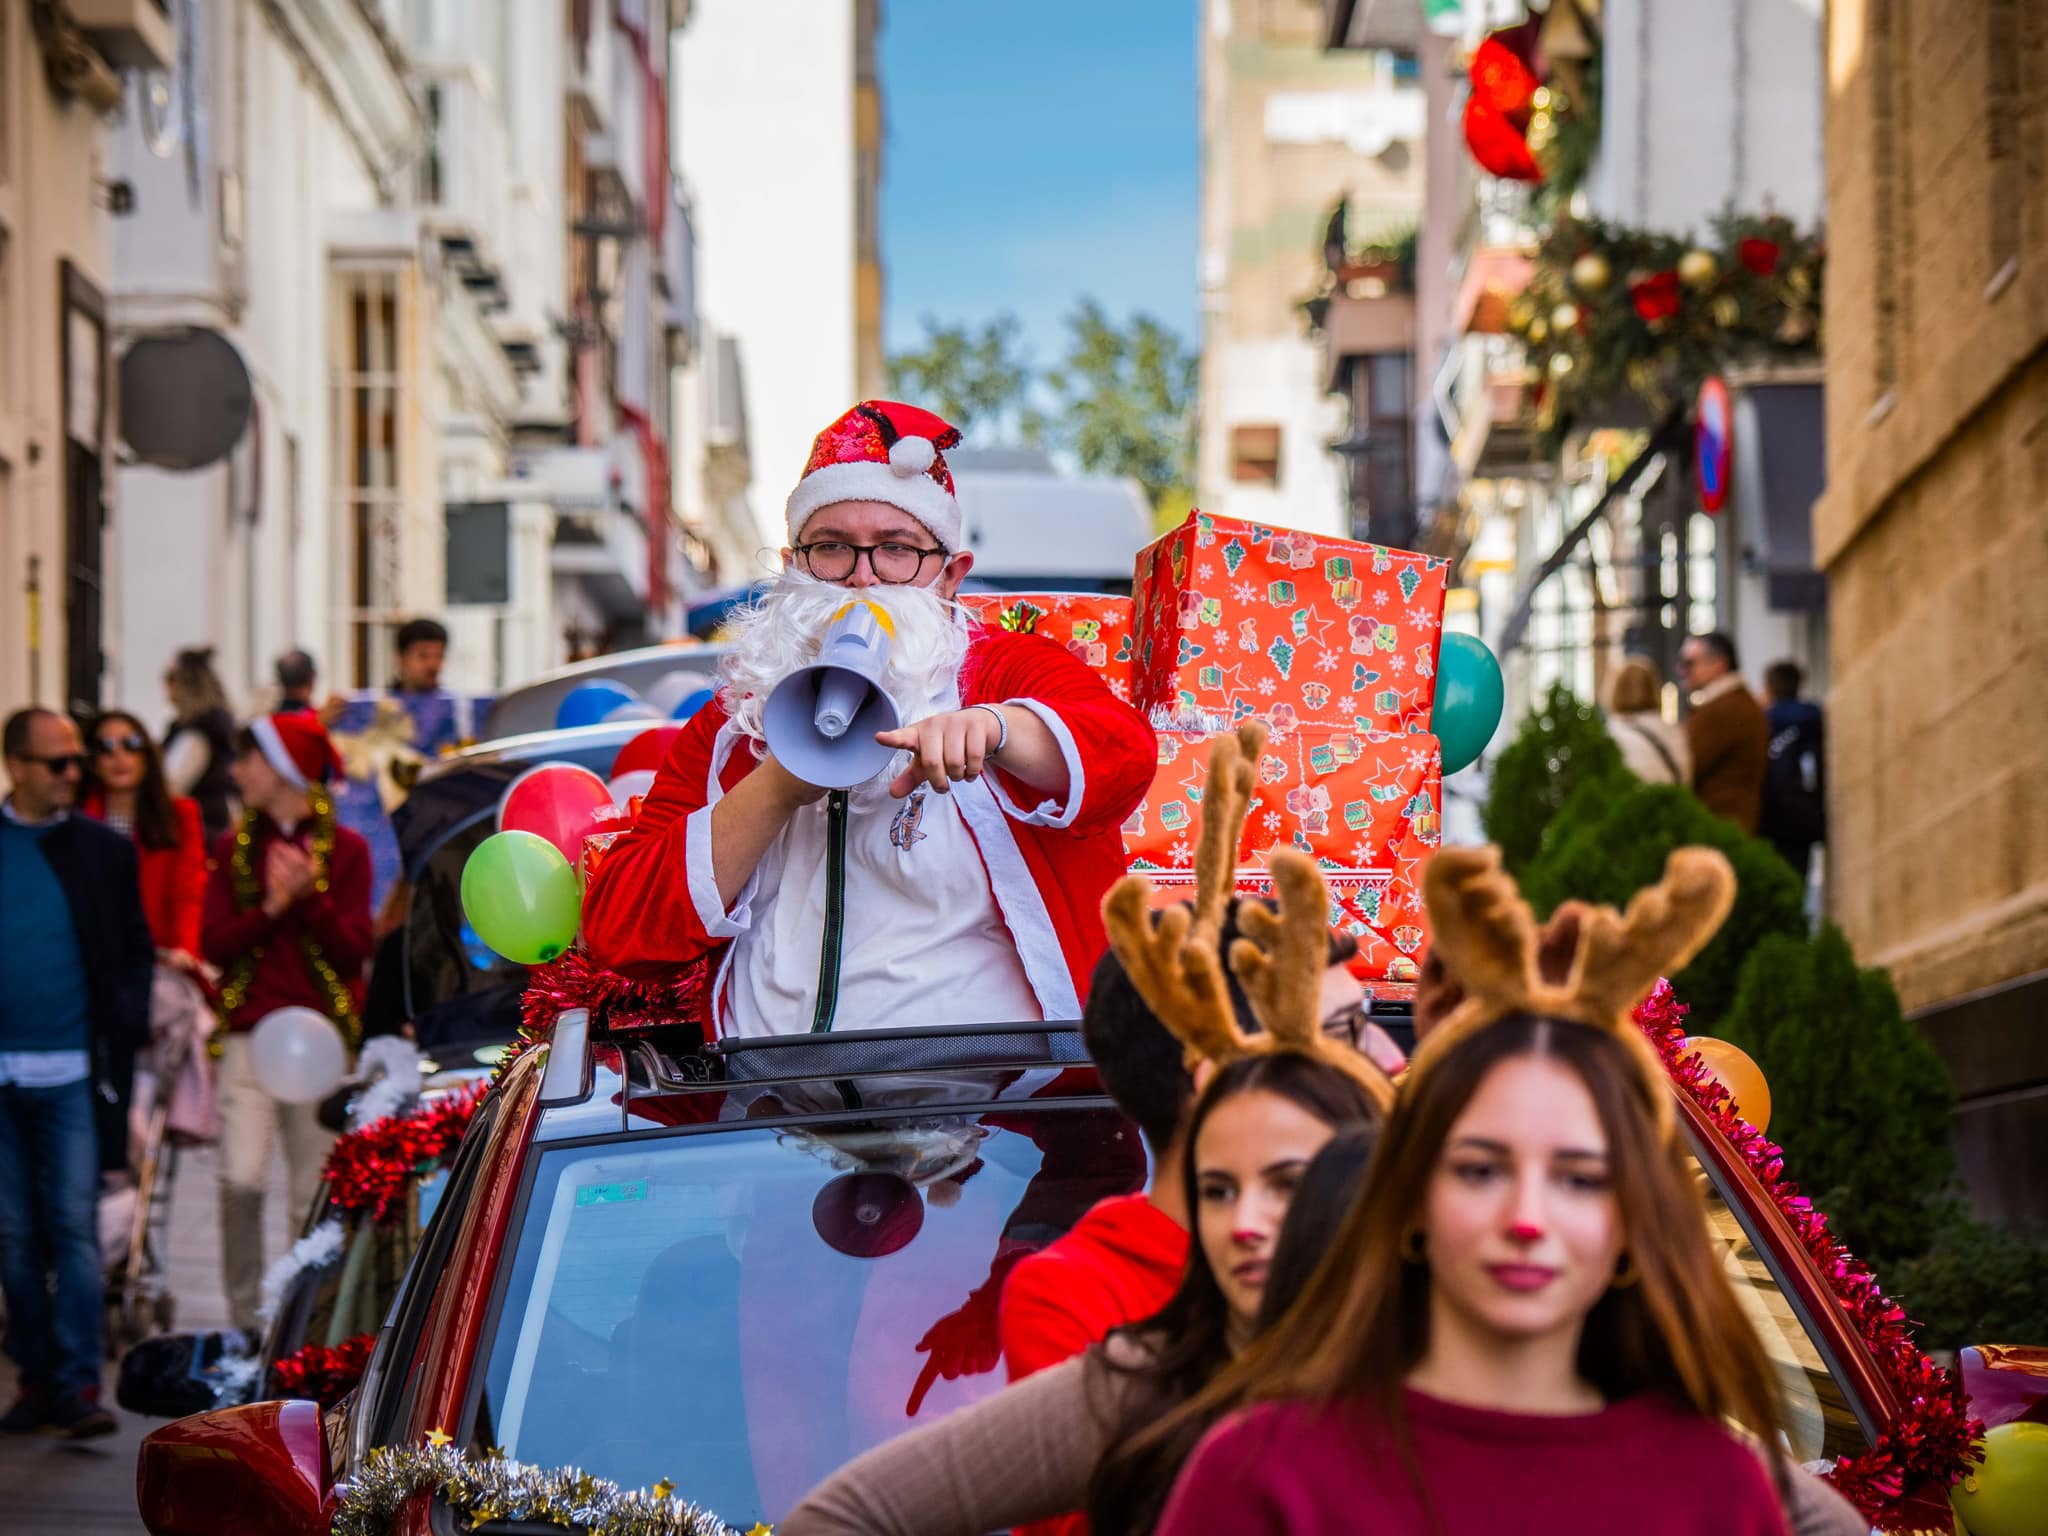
[584,401,1157,1036]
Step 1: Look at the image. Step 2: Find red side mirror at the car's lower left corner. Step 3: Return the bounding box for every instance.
[135,1403,330,1536]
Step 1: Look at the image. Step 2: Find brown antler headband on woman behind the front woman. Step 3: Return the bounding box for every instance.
[1102,721,1393,1112]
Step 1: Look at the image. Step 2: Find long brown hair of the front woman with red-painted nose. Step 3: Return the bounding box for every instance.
[1159,1014,1782,1489]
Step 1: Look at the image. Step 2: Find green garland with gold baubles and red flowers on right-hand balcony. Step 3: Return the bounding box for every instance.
[1507,213,1825,451]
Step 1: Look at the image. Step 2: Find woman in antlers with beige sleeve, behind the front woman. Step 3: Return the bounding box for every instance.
[778,731,1393,1536]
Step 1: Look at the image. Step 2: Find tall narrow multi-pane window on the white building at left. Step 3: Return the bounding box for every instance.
[328,266,406,688]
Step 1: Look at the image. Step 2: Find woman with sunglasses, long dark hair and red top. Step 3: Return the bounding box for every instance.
[84,709,207,971]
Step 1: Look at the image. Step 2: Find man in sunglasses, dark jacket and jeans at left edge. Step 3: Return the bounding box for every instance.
[0,709,156,1440]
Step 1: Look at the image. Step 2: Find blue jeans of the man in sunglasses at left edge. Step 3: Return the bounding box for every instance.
[0,1081,104,1393]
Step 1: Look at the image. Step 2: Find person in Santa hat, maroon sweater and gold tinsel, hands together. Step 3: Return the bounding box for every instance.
[203,713,371,1331]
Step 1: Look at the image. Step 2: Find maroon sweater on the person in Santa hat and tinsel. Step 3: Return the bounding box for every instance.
[201,817,371,1030]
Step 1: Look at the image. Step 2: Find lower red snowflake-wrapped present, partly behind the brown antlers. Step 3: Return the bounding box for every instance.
[1124,725,1444,981]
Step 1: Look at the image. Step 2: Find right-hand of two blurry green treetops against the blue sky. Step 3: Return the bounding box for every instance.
[1047,299,1196,508]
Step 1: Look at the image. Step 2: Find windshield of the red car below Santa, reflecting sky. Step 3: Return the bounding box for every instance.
[469,1104,1145,1530]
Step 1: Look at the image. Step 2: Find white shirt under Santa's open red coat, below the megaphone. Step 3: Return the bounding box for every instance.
[719,770,1040,1038]
